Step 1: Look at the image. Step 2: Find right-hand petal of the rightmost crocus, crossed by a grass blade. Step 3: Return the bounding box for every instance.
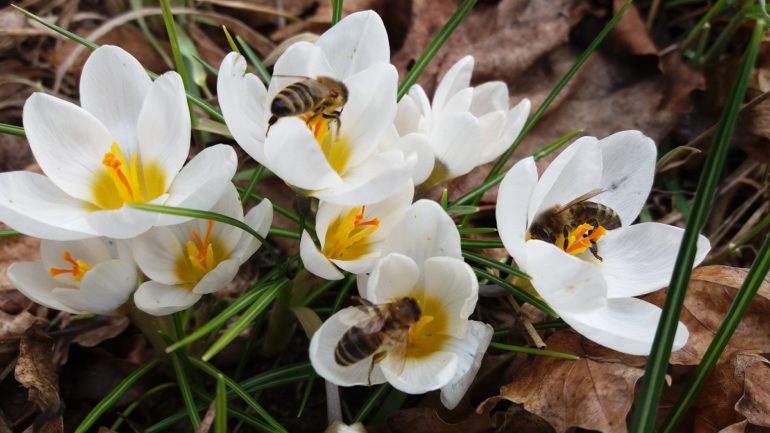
[596,222,711,298]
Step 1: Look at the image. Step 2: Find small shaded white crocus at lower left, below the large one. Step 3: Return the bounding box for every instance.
[8,238,138,314]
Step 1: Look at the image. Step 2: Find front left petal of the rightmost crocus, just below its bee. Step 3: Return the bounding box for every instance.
[526,240,607,315]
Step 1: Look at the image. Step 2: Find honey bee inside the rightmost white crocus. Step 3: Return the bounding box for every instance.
[529,189,621,261]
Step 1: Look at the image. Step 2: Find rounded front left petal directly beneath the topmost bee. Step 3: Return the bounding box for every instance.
[265,117,342,190]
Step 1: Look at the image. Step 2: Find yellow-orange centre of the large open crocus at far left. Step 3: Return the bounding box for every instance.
[93,143,165,209]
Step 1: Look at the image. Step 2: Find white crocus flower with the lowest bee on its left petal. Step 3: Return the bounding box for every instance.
[310,200,492,408]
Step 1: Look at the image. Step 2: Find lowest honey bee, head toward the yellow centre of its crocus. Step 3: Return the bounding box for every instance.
[334,297,422,385]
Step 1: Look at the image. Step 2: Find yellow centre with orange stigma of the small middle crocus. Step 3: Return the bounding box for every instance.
[322,206,380,260]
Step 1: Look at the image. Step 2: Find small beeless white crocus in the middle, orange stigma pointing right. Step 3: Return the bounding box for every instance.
[299,182,414,280]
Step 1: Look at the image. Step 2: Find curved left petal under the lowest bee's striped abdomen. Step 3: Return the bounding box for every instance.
[309,307,385,386]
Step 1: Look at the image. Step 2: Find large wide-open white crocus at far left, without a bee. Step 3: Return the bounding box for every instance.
[0,46,236,240]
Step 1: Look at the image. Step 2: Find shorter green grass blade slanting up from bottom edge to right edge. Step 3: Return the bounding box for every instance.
[658,230,770,433]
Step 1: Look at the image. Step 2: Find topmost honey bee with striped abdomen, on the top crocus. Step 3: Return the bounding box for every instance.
[267,77,348,131]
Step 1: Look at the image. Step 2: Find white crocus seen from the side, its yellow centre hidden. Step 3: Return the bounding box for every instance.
[395,56,530,187]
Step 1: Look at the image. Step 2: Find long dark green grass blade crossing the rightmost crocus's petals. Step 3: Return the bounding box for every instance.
[629,18,764,433]
